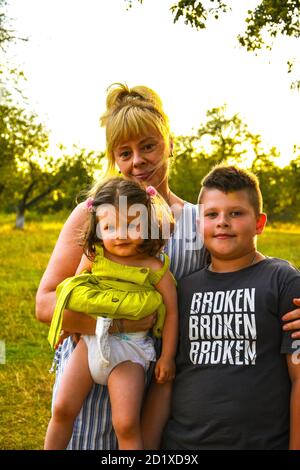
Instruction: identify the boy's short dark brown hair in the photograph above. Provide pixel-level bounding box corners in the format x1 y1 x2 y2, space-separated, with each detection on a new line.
198 164 263 215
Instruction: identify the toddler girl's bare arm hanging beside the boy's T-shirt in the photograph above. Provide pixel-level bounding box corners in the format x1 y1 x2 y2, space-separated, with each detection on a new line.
155 271 178 382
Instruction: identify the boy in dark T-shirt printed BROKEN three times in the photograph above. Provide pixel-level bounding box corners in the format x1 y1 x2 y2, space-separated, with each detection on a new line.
162 166 300 449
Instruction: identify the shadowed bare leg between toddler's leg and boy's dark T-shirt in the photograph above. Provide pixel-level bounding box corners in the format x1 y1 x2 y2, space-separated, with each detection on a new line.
142 379 173 450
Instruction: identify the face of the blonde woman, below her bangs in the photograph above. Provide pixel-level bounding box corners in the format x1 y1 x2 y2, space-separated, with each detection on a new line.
114 134 169 188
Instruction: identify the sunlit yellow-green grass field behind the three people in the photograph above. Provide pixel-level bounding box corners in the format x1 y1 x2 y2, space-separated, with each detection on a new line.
0 214 300 449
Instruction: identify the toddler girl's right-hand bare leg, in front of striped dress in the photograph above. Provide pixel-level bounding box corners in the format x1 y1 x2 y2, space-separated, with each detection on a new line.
107 361 145 450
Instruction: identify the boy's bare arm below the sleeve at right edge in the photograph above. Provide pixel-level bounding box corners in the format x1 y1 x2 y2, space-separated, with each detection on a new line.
286 352 300 450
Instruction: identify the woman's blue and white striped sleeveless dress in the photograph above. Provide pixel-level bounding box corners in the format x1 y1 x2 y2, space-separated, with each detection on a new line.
53 202 208 450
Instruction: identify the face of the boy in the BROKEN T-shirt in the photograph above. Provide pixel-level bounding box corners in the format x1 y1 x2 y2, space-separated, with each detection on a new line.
201 189 266 260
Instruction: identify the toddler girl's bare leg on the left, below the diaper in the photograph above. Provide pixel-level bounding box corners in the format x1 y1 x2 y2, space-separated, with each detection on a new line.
44 339 93 450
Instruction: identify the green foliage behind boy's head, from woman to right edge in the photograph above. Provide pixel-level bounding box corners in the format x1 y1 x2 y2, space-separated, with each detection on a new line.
170 106 300 221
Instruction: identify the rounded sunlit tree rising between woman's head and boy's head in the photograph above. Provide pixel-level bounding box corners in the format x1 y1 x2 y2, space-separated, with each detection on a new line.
170 106 256 202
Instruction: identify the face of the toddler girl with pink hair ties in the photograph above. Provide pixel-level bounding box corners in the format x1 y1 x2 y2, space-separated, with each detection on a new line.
97 206 144 257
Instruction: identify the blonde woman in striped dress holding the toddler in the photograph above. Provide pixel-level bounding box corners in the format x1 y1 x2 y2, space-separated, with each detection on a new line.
36 84 300 449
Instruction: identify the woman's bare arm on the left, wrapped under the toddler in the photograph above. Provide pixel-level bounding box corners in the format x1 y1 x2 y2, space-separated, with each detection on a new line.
36 202 96 334
